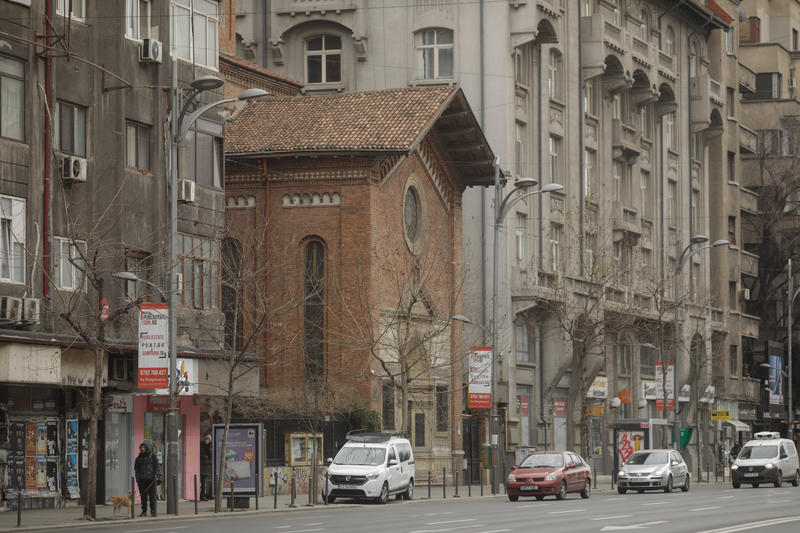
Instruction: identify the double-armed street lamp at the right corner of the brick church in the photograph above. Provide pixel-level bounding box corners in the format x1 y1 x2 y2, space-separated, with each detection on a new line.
489 157 564 494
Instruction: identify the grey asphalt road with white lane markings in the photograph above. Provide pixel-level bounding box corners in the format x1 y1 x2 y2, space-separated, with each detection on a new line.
78 485 800 533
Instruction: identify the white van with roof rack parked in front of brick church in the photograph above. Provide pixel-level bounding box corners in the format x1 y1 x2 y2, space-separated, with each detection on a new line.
322 432 415 503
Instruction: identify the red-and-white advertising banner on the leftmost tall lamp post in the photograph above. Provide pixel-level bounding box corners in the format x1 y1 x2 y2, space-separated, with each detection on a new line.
138 303 169 389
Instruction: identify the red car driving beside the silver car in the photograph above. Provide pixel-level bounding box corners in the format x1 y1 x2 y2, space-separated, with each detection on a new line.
506 451 592 502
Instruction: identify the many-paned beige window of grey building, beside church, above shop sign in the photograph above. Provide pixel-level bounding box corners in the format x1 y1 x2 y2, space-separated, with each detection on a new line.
178 234 220 309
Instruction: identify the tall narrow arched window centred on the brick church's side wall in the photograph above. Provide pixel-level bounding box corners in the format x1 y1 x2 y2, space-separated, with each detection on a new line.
303 237 325 379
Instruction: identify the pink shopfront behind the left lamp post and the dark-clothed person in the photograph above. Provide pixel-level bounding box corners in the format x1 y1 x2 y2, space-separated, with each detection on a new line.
133 394 200 500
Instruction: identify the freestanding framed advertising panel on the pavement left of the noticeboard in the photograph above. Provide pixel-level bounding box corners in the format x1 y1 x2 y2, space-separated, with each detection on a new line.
213 424 261 494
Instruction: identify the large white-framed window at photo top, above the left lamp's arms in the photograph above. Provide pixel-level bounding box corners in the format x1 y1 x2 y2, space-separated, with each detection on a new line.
170 0 219 69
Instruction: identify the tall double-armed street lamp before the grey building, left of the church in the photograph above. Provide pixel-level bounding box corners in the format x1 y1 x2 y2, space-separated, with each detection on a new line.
164 68 268 515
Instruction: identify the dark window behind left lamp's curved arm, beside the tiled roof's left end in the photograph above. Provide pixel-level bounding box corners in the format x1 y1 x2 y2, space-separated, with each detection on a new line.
178 119 222 189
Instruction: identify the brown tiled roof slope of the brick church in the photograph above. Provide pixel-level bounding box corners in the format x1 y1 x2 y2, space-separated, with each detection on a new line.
225 87 458 154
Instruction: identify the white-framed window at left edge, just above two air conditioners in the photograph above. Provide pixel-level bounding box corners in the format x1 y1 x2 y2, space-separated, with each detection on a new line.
0 195 25 283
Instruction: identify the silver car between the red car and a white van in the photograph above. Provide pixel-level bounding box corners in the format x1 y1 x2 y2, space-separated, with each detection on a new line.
617 450 689 494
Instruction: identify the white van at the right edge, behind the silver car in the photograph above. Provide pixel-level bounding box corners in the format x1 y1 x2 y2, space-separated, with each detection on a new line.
731 431 800 489
